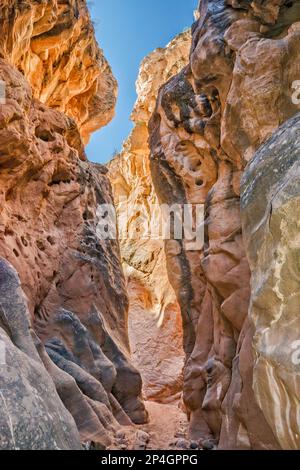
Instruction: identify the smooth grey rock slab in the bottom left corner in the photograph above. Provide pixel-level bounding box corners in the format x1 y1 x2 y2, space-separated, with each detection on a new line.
0 258 81 450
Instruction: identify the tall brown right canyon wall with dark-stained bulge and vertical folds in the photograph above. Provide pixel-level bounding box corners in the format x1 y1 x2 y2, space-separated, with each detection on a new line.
149 0 300 449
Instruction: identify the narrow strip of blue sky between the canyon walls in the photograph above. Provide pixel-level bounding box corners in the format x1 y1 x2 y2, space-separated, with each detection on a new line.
87 0 198 163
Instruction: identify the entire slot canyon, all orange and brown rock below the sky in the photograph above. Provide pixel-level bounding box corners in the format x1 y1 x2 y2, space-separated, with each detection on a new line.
0 0 300 451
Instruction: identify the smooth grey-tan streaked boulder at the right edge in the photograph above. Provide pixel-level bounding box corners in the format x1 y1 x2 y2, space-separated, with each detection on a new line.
241 114 300 449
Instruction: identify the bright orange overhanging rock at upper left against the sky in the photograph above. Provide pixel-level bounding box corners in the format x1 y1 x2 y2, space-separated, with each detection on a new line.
0 0 117 143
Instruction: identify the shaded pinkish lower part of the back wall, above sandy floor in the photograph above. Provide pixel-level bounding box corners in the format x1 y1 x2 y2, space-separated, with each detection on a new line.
128 281 184 403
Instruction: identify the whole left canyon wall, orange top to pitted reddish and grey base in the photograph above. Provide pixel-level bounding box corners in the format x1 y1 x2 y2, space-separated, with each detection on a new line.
0 1 147 449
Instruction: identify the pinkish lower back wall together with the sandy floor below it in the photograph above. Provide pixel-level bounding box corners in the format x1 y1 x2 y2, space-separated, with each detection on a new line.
118 280 191 450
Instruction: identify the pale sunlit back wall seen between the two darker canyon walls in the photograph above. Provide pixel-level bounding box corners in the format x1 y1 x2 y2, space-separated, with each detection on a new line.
109 31 191 402
